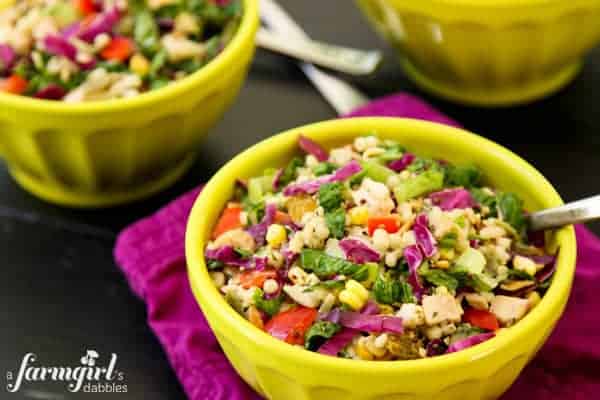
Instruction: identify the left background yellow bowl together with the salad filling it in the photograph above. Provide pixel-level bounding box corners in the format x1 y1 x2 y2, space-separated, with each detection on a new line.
0 0 259 207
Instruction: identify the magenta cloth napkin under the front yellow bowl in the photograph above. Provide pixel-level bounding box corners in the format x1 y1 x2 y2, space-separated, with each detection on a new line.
114 94 600 400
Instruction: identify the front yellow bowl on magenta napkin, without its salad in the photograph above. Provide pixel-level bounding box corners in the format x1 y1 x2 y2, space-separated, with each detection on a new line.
185 118 576 400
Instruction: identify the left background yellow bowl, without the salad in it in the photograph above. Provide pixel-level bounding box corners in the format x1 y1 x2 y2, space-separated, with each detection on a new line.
0 0 259 207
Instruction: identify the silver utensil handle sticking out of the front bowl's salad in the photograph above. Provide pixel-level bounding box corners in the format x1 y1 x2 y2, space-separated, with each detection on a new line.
529 195 600 231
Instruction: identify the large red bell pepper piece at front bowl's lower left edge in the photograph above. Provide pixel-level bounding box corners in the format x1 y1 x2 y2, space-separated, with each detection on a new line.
265 306 317 345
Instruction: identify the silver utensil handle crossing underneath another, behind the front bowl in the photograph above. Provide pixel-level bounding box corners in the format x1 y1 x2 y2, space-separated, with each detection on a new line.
260 0 370 115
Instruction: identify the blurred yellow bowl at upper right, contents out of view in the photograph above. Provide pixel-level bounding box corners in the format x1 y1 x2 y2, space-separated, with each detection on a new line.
357 0 600 106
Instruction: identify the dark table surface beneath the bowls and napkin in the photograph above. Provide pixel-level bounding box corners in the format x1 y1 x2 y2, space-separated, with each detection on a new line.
0 0 600 400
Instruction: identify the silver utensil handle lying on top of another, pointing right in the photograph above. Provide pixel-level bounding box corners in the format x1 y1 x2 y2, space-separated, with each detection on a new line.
256 28 382 75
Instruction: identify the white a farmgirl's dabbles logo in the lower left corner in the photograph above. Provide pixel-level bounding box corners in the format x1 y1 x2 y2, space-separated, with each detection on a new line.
6 350 127 393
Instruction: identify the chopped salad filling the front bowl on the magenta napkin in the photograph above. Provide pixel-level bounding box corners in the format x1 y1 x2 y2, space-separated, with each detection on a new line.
205 135 555 360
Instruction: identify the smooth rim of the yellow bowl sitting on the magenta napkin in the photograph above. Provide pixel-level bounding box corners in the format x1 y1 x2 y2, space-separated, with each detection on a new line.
185 117 576 374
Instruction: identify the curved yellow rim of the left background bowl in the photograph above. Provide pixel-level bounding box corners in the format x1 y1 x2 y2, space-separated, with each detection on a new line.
0 0 259 114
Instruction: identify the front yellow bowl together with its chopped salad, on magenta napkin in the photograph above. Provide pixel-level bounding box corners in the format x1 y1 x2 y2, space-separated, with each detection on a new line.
186 118 576 400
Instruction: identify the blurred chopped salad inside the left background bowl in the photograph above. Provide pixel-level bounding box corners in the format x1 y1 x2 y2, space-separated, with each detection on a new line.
0 0 242 102
